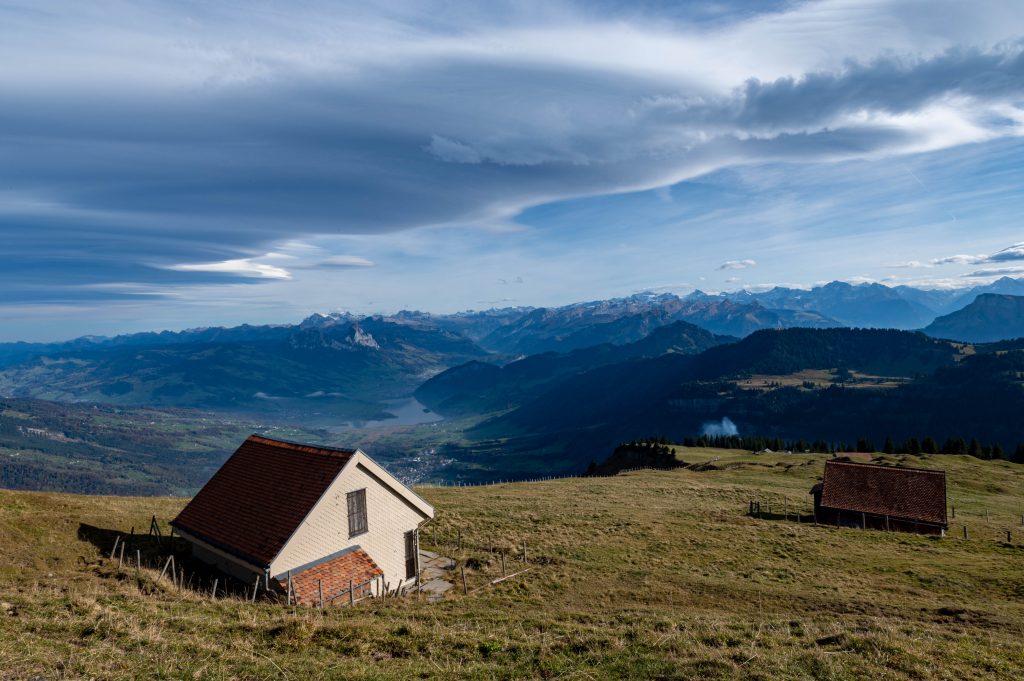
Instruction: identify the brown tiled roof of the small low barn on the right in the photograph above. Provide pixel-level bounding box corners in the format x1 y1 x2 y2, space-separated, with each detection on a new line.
821 461 946 525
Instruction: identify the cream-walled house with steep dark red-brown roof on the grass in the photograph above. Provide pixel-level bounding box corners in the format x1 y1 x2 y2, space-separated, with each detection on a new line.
171 435 434 604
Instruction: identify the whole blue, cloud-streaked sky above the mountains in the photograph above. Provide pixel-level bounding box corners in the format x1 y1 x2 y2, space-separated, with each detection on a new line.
0 0 1024 341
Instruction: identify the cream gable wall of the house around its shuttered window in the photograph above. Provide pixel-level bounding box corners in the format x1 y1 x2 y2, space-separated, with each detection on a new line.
270 459 424 588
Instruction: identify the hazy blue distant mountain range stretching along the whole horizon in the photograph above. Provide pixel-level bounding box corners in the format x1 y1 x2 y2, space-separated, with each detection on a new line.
0 278 1024 422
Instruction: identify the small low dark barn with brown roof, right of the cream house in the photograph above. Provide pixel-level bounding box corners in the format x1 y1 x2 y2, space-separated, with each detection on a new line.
811 461 949 536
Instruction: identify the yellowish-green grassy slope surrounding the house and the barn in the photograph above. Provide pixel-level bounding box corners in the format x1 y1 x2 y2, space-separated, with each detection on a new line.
0 450 1024 679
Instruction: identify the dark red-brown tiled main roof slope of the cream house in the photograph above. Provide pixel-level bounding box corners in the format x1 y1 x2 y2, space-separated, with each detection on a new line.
171 435 355 567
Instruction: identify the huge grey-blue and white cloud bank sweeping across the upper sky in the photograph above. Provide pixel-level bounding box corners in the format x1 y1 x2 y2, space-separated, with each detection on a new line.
6 0 1024 333
